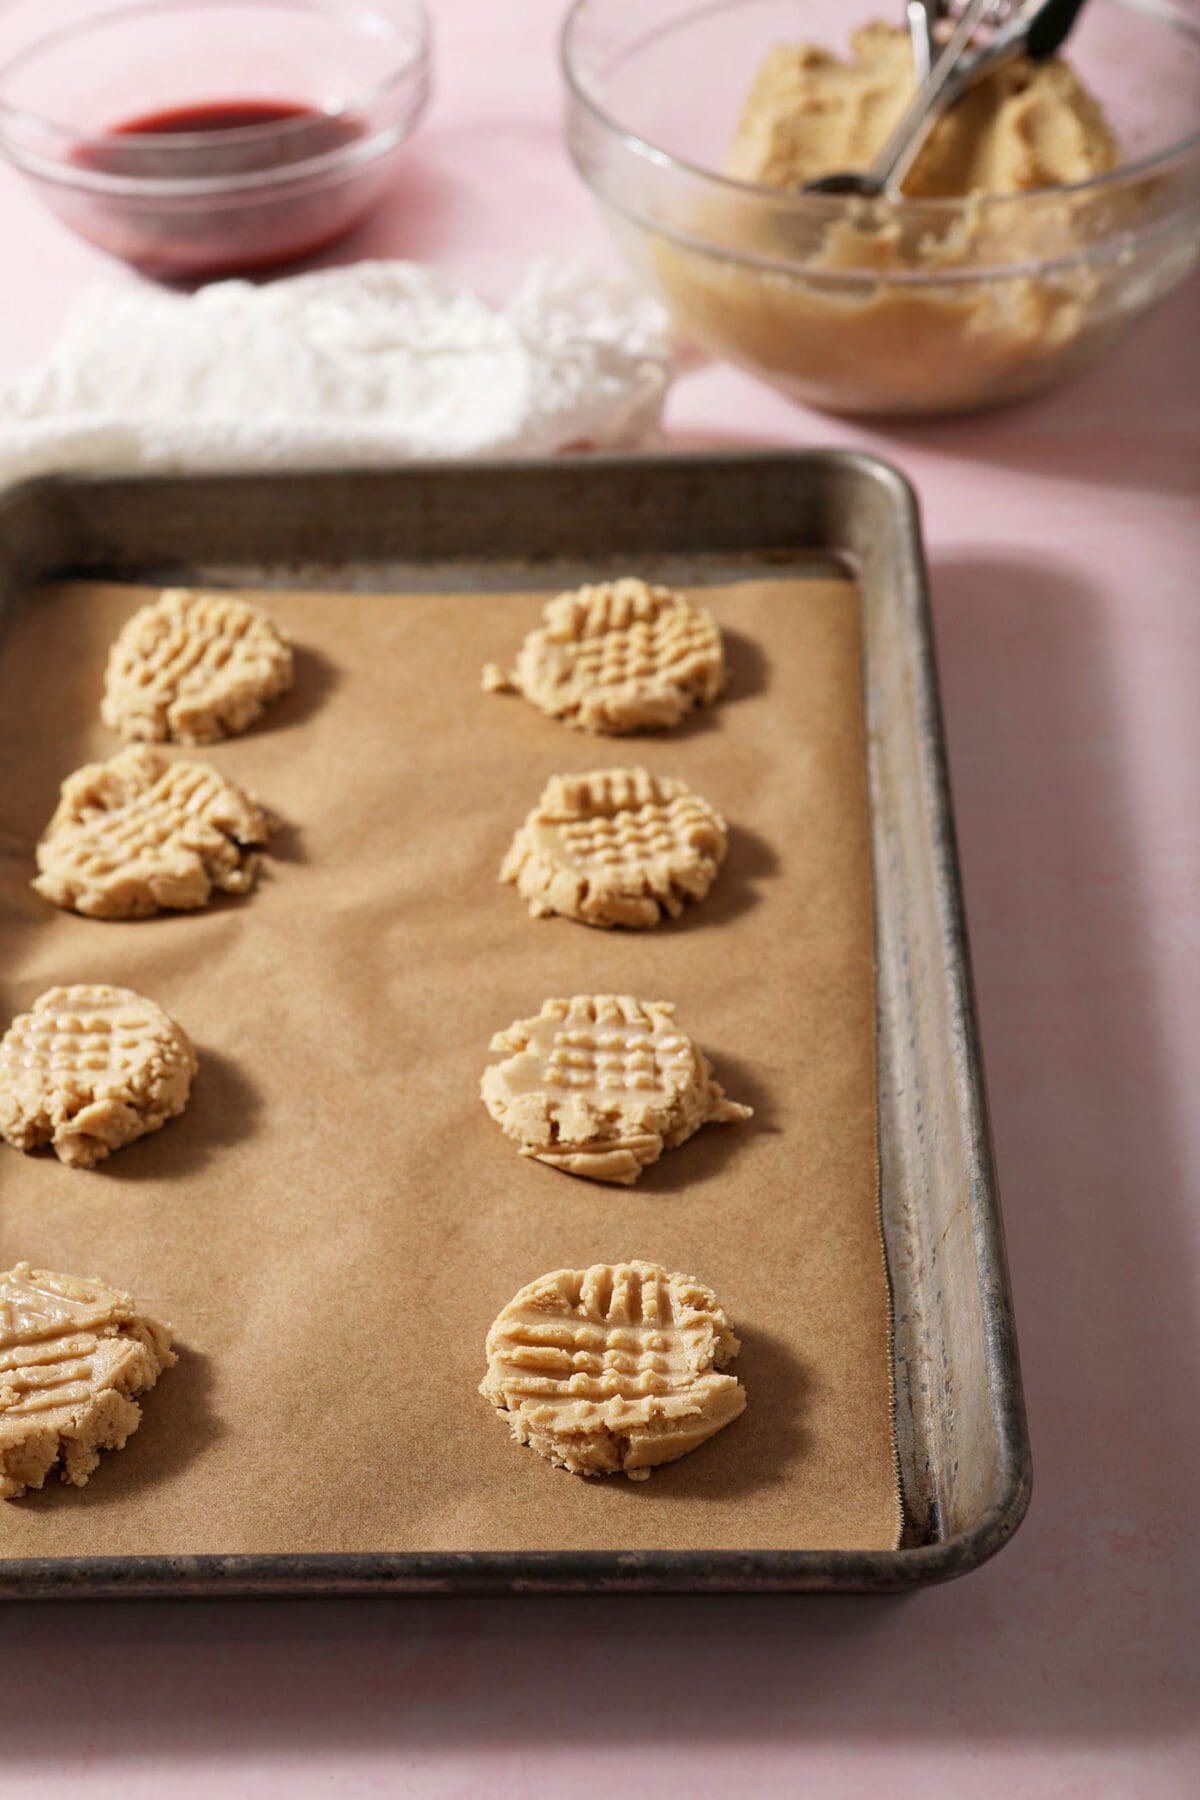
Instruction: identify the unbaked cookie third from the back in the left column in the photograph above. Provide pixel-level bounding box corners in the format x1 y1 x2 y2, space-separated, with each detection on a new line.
0 986 196 1168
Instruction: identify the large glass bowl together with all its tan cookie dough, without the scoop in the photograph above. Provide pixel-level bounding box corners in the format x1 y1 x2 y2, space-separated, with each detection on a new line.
565 0 1200 414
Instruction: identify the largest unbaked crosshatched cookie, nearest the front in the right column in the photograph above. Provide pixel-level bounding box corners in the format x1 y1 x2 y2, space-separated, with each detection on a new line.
479 1262 747 1481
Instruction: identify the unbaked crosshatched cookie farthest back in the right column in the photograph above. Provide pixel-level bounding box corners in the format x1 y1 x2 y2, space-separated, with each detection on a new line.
484 576 725 734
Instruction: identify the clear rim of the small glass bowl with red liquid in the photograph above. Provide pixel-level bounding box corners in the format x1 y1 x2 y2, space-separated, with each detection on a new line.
0 0 432 198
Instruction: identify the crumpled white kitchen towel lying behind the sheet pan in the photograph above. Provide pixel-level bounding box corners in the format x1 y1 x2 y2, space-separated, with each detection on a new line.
0 261 671 484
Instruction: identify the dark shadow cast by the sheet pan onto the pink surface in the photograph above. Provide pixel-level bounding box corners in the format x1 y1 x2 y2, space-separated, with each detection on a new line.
0 553 1200 1756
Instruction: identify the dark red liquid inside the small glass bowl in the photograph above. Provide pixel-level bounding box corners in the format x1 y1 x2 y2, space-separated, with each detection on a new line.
59 101 380 281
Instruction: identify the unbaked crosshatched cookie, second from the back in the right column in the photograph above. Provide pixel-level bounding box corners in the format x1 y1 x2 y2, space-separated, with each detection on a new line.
500 769 727 925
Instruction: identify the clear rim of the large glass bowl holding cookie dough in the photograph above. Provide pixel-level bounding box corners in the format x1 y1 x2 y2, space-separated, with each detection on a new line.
558 0 1200 220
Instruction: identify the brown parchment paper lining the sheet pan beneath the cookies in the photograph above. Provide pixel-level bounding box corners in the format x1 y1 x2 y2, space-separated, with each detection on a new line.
0 580 900 1557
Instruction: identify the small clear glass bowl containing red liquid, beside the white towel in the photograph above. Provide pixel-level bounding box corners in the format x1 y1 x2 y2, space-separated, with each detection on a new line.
0 0 430 281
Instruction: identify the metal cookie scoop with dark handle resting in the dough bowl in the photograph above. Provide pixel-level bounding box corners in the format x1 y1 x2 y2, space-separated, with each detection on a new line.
802 0 1083 200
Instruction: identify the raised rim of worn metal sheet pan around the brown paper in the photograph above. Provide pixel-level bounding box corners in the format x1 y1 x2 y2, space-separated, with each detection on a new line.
0 452 1029 1598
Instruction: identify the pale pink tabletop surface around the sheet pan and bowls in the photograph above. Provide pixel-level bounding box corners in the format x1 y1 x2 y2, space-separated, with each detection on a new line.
0 0 1200 1800
